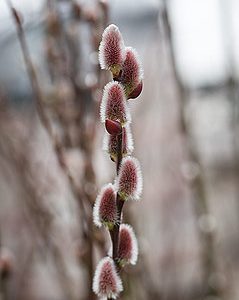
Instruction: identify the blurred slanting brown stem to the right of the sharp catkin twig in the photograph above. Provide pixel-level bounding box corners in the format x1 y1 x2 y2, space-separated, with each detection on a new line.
161 0 220 297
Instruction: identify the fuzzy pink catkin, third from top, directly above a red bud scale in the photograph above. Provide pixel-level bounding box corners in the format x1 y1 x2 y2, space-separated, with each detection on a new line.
100 81 131 126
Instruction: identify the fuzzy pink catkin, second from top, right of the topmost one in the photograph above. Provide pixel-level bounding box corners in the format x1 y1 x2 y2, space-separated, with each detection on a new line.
120 47 143 95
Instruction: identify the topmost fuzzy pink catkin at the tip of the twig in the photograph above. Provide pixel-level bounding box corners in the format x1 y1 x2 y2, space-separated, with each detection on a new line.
99 24 125 77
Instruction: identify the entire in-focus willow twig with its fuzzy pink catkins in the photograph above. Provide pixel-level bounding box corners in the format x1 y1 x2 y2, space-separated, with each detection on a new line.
93 24 143 299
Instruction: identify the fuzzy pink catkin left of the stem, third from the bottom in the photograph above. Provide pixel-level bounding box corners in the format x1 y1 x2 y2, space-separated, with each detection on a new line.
93 183 117 230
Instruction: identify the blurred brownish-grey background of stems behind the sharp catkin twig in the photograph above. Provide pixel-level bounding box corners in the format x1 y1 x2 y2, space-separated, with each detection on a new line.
0 0 239 300
